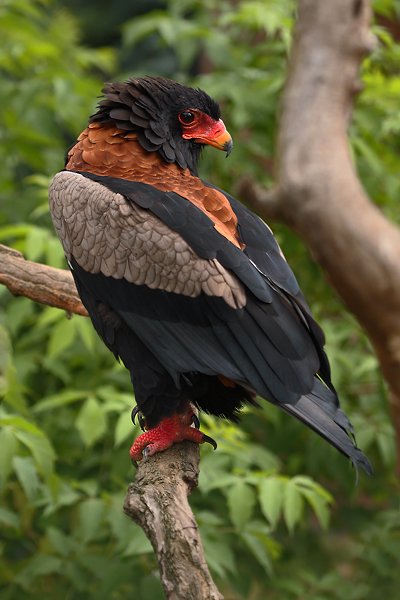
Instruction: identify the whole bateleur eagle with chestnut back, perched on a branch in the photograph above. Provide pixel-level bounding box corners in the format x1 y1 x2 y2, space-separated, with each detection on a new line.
50 77 371 473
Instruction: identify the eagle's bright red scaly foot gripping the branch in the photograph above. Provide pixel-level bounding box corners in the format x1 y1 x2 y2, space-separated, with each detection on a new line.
130 405 217 461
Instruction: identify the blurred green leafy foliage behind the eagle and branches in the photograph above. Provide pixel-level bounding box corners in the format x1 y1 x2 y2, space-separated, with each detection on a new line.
0 0 400 600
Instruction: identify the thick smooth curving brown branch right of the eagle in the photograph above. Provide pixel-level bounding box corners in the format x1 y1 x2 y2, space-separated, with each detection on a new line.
241 0 400 465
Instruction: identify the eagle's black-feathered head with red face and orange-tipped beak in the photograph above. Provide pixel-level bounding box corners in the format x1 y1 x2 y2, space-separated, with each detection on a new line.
90 77 233 173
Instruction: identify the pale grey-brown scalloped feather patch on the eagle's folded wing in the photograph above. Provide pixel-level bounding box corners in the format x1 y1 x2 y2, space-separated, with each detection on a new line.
49 171 246 308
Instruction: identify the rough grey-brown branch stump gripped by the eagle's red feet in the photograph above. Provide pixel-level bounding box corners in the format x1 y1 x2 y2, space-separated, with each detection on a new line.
124 442 223 600
